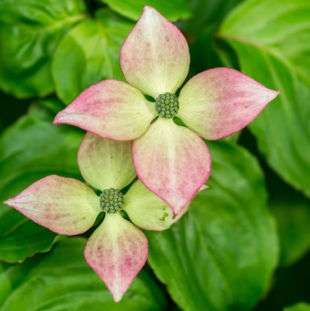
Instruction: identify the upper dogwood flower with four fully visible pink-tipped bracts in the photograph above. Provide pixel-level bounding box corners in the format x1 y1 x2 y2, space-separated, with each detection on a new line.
54 6 278 215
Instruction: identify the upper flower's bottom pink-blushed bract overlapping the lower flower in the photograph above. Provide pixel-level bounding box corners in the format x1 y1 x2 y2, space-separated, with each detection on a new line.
132 118 211 215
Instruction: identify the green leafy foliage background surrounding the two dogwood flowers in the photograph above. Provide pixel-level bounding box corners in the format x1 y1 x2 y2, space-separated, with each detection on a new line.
0 0 310 311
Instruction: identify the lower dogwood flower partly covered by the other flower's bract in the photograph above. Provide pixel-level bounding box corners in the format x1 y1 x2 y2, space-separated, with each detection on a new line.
5 133 188 302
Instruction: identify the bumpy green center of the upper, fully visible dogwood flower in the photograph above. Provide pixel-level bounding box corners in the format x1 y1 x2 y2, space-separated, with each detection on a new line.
156 93 179 118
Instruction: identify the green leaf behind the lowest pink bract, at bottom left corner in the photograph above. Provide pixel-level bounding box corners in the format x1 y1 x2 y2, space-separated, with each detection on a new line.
0 238 166 311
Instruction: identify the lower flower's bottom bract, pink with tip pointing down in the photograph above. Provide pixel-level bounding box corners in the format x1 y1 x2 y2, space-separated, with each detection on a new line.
84 213 148 301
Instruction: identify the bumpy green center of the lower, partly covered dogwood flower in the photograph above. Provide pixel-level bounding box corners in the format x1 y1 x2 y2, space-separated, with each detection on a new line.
100 188 124 213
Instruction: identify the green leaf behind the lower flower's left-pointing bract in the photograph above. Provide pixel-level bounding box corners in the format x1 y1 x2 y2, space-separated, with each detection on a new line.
0 100 82 262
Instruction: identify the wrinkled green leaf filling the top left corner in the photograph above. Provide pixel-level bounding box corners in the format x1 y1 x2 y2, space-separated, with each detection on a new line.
0 0 86 98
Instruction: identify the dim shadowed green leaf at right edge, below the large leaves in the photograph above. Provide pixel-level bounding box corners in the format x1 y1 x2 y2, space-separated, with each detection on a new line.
270 193 310 266
